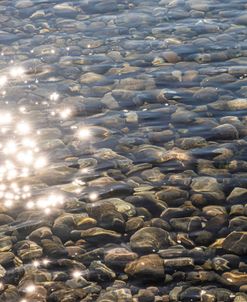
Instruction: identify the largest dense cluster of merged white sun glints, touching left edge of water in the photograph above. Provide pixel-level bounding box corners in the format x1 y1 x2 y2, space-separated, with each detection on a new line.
0 111 48 209
